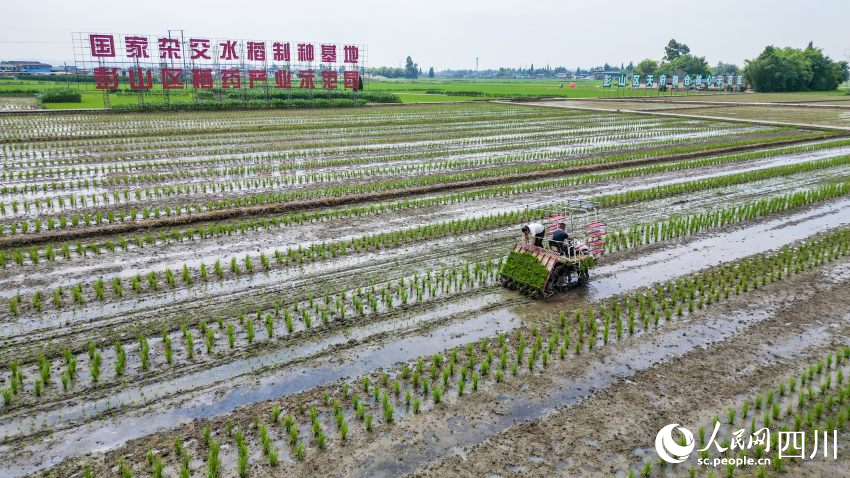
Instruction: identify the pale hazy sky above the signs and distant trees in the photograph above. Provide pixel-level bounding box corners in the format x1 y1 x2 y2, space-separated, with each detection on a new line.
0 0 850 71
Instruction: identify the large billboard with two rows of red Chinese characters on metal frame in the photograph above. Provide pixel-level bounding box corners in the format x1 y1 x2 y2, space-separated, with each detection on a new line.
73 31 366 91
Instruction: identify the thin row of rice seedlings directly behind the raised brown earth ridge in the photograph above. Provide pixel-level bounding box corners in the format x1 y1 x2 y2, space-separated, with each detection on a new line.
0 129 829 235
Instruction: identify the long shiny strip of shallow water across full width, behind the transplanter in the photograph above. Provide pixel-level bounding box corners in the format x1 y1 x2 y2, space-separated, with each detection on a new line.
0 142 850 296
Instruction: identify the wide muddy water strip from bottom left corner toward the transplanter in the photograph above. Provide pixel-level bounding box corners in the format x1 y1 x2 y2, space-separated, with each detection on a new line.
0 298 519 477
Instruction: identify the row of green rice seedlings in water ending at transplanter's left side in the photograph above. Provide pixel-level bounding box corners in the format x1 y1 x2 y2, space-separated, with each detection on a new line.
0 259 501 405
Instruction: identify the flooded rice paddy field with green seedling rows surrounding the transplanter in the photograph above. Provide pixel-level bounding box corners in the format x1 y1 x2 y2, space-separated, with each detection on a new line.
0 102 850 478
